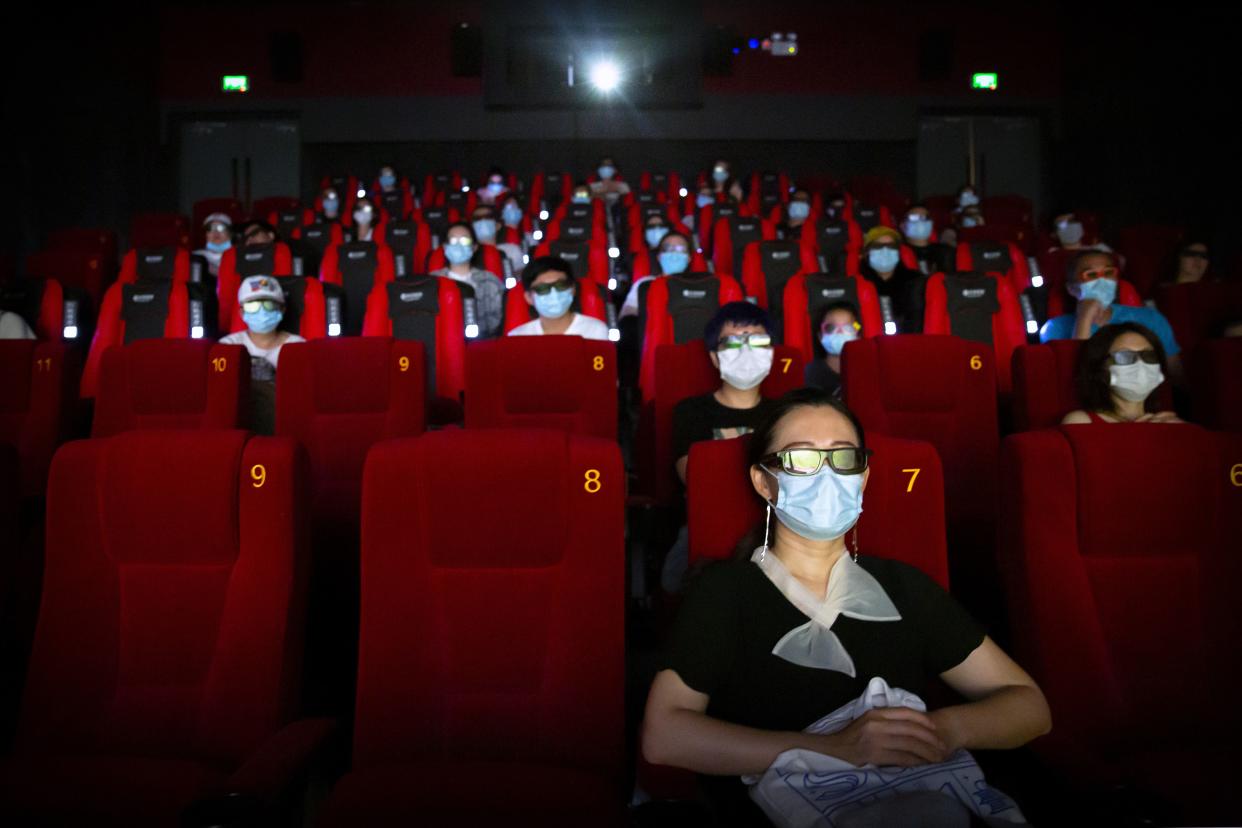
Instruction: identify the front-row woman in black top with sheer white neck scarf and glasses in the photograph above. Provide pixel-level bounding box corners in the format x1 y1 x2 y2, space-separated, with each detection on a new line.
641 389 1051 826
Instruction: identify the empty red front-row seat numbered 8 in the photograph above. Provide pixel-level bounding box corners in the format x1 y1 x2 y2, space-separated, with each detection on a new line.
320 431 627 827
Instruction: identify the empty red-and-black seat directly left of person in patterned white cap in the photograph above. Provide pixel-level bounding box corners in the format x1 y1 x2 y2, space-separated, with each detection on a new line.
82 282 193 397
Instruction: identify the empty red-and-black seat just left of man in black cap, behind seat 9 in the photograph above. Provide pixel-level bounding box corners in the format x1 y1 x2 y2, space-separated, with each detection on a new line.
363 276 466 413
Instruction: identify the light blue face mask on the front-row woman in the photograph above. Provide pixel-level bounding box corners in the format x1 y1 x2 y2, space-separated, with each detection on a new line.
764 463 863 540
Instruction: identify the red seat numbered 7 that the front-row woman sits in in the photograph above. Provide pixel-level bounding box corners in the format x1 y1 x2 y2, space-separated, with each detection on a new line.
686 433 949 588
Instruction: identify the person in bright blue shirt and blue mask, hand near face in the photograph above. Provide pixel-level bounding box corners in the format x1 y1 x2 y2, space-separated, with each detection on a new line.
1040 250 1182 382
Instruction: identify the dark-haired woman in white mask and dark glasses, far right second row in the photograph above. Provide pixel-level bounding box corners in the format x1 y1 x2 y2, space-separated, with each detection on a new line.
1061 322 1181 425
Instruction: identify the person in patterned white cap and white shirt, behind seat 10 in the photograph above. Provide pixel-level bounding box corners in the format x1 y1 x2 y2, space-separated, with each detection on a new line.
220 276 306 434
